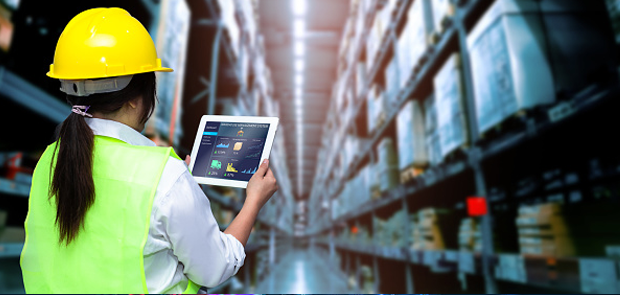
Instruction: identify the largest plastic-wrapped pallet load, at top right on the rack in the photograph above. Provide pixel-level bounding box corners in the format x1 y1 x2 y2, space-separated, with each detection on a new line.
467 0 616 133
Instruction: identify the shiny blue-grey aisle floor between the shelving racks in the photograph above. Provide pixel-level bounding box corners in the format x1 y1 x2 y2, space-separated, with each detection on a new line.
254 248 349 294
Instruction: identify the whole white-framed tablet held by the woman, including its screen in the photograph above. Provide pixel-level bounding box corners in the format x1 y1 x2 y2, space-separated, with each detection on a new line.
189 115 279 188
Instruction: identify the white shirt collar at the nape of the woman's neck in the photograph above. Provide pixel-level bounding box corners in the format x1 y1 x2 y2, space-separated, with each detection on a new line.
84 118 157 146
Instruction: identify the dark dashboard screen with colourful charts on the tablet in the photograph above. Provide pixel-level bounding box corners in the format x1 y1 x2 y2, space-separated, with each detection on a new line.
192 122 269 181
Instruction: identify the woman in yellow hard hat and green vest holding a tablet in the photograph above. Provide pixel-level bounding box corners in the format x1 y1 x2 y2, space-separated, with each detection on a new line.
21 8 277 293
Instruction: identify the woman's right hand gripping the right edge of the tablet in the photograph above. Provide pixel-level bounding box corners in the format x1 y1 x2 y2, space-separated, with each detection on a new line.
245 159 278 210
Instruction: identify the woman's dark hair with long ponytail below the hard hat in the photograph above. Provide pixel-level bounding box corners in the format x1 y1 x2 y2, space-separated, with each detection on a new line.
49 72 156 245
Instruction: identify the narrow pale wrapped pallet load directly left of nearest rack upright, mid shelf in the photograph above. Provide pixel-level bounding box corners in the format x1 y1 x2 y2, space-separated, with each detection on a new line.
433 53 468 158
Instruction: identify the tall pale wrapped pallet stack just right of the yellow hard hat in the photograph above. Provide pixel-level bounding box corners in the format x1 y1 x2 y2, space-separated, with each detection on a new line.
154 0 191 145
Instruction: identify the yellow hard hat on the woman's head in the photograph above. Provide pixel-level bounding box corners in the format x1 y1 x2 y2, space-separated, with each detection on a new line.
47 8 172 80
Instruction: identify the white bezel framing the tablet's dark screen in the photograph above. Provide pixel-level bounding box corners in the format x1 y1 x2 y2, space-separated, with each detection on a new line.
189 115 280 188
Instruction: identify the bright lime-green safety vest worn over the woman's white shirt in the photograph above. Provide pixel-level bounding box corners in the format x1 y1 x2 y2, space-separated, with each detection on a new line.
20 136 199 294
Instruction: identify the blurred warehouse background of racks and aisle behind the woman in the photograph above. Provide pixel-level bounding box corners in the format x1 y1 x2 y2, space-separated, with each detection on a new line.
0 0 620 293
